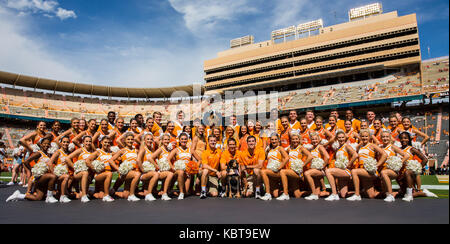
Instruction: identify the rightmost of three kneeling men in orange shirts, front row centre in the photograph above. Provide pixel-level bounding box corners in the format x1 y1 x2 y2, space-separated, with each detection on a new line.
238 136 266 198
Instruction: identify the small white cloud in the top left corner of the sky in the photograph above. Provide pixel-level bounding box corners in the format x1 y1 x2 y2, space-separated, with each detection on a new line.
0 0 77 20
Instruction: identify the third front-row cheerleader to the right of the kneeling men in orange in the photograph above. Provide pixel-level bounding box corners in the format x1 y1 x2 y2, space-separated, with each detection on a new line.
304 132 330 200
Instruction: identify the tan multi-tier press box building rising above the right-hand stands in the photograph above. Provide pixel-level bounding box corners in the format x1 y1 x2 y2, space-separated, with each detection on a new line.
204 7 421 94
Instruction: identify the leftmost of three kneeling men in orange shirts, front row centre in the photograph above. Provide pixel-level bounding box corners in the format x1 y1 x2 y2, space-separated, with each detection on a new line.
200 135 222 199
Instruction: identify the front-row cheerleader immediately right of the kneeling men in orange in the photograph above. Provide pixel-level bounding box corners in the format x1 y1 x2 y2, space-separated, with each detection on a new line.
261 133 289 201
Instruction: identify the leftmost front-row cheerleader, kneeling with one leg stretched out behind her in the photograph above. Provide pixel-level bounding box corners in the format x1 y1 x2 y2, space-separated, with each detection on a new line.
6 138 58 203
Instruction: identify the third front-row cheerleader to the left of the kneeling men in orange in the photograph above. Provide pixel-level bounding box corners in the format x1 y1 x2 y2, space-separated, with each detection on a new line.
137 133 160 201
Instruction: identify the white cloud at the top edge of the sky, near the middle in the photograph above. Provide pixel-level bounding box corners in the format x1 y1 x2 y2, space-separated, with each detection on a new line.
169 0 257 32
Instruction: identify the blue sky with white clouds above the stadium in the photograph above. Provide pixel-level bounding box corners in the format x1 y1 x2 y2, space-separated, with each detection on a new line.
0 0 449 87
